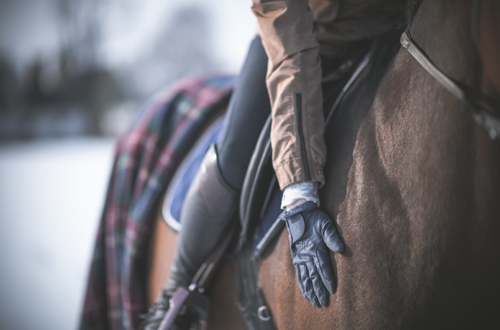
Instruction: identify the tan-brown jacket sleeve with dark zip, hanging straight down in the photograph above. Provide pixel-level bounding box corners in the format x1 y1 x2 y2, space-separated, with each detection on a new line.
252 0 326 189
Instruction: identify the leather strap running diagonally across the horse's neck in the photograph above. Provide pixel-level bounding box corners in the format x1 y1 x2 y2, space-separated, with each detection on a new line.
400 29 500 140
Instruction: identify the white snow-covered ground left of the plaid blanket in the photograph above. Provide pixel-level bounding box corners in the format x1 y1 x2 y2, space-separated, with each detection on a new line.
0 139 113 330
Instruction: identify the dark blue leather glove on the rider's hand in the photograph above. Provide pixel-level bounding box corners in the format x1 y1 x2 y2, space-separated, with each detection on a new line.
280 202 344 307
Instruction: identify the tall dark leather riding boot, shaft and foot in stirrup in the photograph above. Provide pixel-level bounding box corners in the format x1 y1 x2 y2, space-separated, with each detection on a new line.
139 145 239 330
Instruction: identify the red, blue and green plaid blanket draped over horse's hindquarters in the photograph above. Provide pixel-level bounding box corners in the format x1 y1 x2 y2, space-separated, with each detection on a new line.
79 75 235 330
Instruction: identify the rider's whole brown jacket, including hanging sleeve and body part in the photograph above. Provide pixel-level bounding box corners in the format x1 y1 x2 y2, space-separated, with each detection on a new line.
252 0 405 189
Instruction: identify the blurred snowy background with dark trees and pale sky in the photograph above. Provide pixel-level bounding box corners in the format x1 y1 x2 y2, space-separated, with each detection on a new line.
0 0 256 330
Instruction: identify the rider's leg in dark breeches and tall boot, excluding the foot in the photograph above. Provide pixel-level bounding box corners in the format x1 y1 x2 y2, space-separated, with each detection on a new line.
167 37 271 293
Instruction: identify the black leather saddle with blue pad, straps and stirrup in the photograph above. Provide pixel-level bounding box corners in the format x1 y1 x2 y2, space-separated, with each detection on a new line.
159 44 370 330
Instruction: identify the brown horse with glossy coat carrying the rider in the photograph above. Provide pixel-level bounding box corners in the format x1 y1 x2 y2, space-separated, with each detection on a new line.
149 0 500 329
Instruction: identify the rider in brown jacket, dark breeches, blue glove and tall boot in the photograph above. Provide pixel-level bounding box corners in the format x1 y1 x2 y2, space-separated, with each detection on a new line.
141 0 405 329
